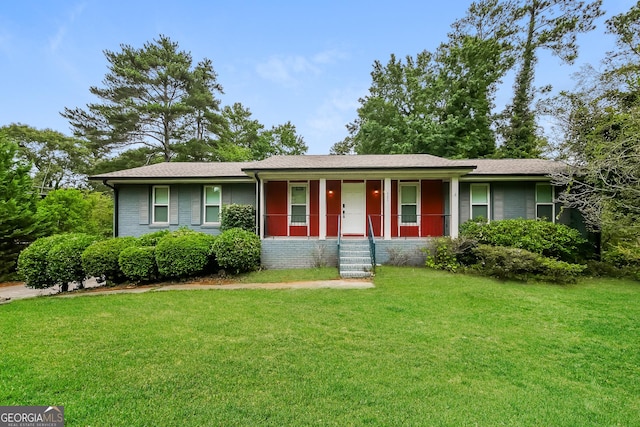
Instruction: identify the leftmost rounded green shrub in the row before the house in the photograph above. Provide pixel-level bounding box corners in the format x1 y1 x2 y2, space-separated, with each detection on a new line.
18 234 66 289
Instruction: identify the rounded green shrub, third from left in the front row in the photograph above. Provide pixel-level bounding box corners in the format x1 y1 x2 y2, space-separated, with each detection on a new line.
82 237 138 283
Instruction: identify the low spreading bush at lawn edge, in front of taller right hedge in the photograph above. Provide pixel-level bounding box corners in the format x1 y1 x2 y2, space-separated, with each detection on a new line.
472 244 586 283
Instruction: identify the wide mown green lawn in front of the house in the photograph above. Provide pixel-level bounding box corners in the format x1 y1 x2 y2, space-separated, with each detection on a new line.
0 267 640 426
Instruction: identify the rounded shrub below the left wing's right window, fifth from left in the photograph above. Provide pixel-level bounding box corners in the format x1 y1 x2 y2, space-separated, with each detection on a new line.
155 229 216 277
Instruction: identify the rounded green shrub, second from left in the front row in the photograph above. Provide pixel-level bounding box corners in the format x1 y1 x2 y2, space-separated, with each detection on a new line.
47 233 98 291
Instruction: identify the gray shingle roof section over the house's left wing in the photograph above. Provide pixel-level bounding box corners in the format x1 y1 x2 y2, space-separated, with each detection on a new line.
90 162 249 180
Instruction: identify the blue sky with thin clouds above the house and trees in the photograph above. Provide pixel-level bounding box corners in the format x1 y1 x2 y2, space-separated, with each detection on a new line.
0 0 635 154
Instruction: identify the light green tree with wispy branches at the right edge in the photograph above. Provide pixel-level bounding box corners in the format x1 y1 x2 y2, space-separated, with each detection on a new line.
550 4 640 239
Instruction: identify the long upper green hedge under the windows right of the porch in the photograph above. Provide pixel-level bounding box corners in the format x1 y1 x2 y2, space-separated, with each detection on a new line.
460 219 587 262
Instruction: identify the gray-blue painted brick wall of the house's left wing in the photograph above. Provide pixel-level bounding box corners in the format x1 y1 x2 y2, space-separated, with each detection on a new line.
117 183 255 237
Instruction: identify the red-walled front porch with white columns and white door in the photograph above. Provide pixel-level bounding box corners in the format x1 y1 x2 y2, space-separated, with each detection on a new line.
258 177 459 240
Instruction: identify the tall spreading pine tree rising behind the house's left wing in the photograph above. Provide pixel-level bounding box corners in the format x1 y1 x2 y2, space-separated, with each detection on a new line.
62 35 222 161
